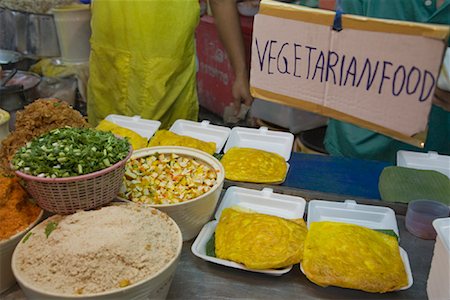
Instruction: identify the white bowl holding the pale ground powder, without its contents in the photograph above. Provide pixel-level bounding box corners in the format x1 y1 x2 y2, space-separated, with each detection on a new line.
11 205 183 300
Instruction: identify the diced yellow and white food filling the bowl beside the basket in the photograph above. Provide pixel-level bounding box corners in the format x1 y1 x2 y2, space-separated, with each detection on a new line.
120 153 217 204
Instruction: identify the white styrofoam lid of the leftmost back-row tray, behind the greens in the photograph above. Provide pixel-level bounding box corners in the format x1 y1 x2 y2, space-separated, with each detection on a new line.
105 115 161 139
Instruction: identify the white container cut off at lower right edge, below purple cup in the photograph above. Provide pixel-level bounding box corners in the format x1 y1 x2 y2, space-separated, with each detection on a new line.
427 218 450 300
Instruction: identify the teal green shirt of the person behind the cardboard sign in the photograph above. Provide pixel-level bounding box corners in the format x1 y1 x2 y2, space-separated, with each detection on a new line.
324 0 450 163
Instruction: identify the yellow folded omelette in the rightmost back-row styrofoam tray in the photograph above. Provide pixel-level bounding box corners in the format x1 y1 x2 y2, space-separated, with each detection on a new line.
220 147 287 183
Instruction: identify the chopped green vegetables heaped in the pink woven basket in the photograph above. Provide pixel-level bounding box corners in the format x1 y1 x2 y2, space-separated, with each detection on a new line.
12 128 130 178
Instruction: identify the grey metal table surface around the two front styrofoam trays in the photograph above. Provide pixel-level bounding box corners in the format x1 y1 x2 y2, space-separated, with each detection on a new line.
0 182 434 300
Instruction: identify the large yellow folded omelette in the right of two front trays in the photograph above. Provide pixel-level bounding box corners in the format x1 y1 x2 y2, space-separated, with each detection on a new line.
302 222 408 293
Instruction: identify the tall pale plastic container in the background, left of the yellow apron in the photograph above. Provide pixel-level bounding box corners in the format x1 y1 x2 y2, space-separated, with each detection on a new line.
52 4 91 64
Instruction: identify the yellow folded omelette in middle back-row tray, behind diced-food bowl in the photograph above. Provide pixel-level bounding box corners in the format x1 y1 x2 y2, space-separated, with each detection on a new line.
148 130 216 155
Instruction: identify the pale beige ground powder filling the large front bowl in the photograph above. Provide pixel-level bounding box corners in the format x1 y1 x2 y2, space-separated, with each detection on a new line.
13 204 181 295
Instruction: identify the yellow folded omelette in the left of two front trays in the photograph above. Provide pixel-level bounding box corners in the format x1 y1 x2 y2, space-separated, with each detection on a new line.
215 208 307 270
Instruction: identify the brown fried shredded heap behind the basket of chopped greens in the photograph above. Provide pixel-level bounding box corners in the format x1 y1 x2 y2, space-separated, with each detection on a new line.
0 99 89 174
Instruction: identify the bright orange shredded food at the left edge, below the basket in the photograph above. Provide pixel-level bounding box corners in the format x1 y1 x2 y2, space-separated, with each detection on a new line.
0 177 41 240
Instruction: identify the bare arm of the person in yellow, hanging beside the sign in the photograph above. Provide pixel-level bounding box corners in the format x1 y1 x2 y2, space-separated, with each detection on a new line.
209 0 253 114
